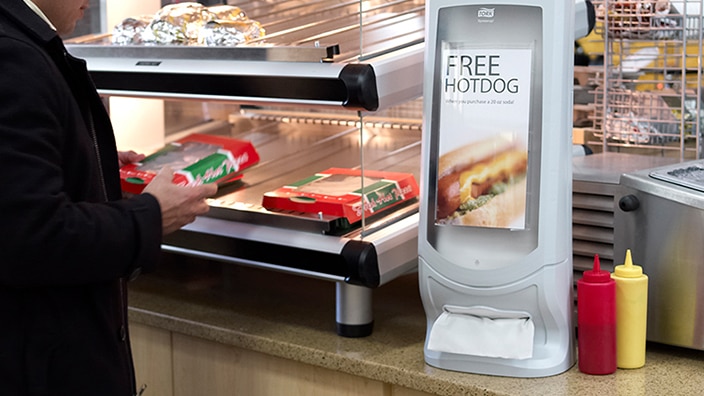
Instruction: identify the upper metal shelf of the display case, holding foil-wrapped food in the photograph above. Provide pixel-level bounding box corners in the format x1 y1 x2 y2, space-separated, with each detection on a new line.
66 0 424 112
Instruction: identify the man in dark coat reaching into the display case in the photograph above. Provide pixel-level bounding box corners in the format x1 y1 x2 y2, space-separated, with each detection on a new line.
0 0 217 396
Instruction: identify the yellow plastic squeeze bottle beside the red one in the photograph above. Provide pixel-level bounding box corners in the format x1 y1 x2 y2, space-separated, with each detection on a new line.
611 249 648 369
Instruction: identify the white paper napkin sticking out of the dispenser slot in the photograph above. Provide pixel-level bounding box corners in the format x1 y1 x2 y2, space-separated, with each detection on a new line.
428 306 535 359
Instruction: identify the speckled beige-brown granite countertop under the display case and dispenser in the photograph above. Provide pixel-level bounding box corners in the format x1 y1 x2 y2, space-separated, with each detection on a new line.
130 256 704 396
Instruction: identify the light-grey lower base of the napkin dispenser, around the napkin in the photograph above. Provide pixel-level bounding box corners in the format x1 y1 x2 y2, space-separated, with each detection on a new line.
418 257 576 378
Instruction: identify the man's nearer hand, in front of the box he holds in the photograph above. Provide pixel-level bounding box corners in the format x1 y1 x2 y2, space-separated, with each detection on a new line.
142 168 218 235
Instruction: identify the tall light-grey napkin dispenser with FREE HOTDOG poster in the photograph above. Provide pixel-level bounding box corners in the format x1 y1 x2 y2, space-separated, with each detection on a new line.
419 0 575 377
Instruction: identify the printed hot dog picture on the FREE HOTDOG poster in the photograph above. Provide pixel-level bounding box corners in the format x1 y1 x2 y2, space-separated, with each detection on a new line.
436 135 528 228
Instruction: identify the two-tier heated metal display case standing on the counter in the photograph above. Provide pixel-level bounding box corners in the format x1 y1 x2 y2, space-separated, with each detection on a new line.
67 0 424 337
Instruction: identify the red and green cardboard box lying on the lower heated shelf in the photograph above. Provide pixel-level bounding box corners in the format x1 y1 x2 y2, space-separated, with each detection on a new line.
262 168 419 224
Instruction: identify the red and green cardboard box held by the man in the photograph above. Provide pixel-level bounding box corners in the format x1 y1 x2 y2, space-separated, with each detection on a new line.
120 133 259 194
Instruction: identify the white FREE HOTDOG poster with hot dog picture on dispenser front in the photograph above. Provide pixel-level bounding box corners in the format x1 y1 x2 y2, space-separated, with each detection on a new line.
435 42 533 229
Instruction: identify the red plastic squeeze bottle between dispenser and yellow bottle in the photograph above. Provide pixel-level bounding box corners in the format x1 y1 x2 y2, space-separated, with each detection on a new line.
577 255 616 375
